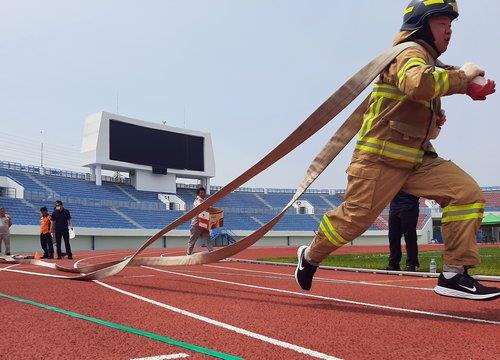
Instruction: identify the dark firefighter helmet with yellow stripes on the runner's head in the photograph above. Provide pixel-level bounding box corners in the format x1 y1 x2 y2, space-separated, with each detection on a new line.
401 0 458 30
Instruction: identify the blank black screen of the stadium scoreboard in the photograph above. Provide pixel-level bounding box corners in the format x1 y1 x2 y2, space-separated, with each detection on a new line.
109 119 205 173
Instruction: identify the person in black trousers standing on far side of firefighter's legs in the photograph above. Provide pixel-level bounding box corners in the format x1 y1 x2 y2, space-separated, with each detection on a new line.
385 191 420 271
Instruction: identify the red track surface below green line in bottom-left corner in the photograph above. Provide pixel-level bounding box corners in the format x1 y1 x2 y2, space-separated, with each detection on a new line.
0 290 217 360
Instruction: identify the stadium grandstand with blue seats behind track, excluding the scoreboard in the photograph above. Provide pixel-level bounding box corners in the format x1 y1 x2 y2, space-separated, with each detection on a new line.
0 161 500 253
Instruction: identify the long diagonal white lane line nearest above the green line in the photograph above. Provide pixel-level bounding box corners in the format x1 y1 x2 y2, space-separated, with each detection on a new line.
94 282 339 360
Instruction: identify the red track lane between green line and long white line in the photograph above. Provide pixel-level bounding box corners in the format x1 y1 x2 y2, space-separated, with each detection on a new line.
0 268 328 359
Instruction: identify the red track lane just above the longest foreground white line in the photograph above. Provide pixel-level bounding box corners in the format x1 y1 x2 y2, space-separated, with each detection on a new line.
122 262 497 358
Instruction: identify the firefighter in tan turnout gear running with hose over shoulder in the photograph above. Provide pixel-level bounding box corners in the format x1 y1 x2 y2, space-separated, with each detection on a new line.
295 0 500 300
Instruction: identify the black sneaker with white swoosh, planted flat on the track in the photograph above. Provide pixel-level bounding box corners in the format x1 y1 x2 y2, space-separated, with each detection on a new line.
434 270 500 300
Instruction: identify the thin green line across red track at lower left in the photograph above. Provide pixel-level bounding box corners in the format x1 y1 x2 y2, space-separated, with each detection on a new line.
0 292 243 360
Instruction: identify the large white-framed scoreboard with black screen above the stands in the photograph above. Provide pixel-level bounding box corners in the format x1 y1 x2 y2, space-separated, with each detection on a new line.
81 111 215 193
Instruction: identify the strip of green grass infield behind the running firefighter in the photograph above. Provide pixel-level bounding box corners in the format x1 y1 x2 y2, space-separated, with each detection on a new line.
258 247 500 275
